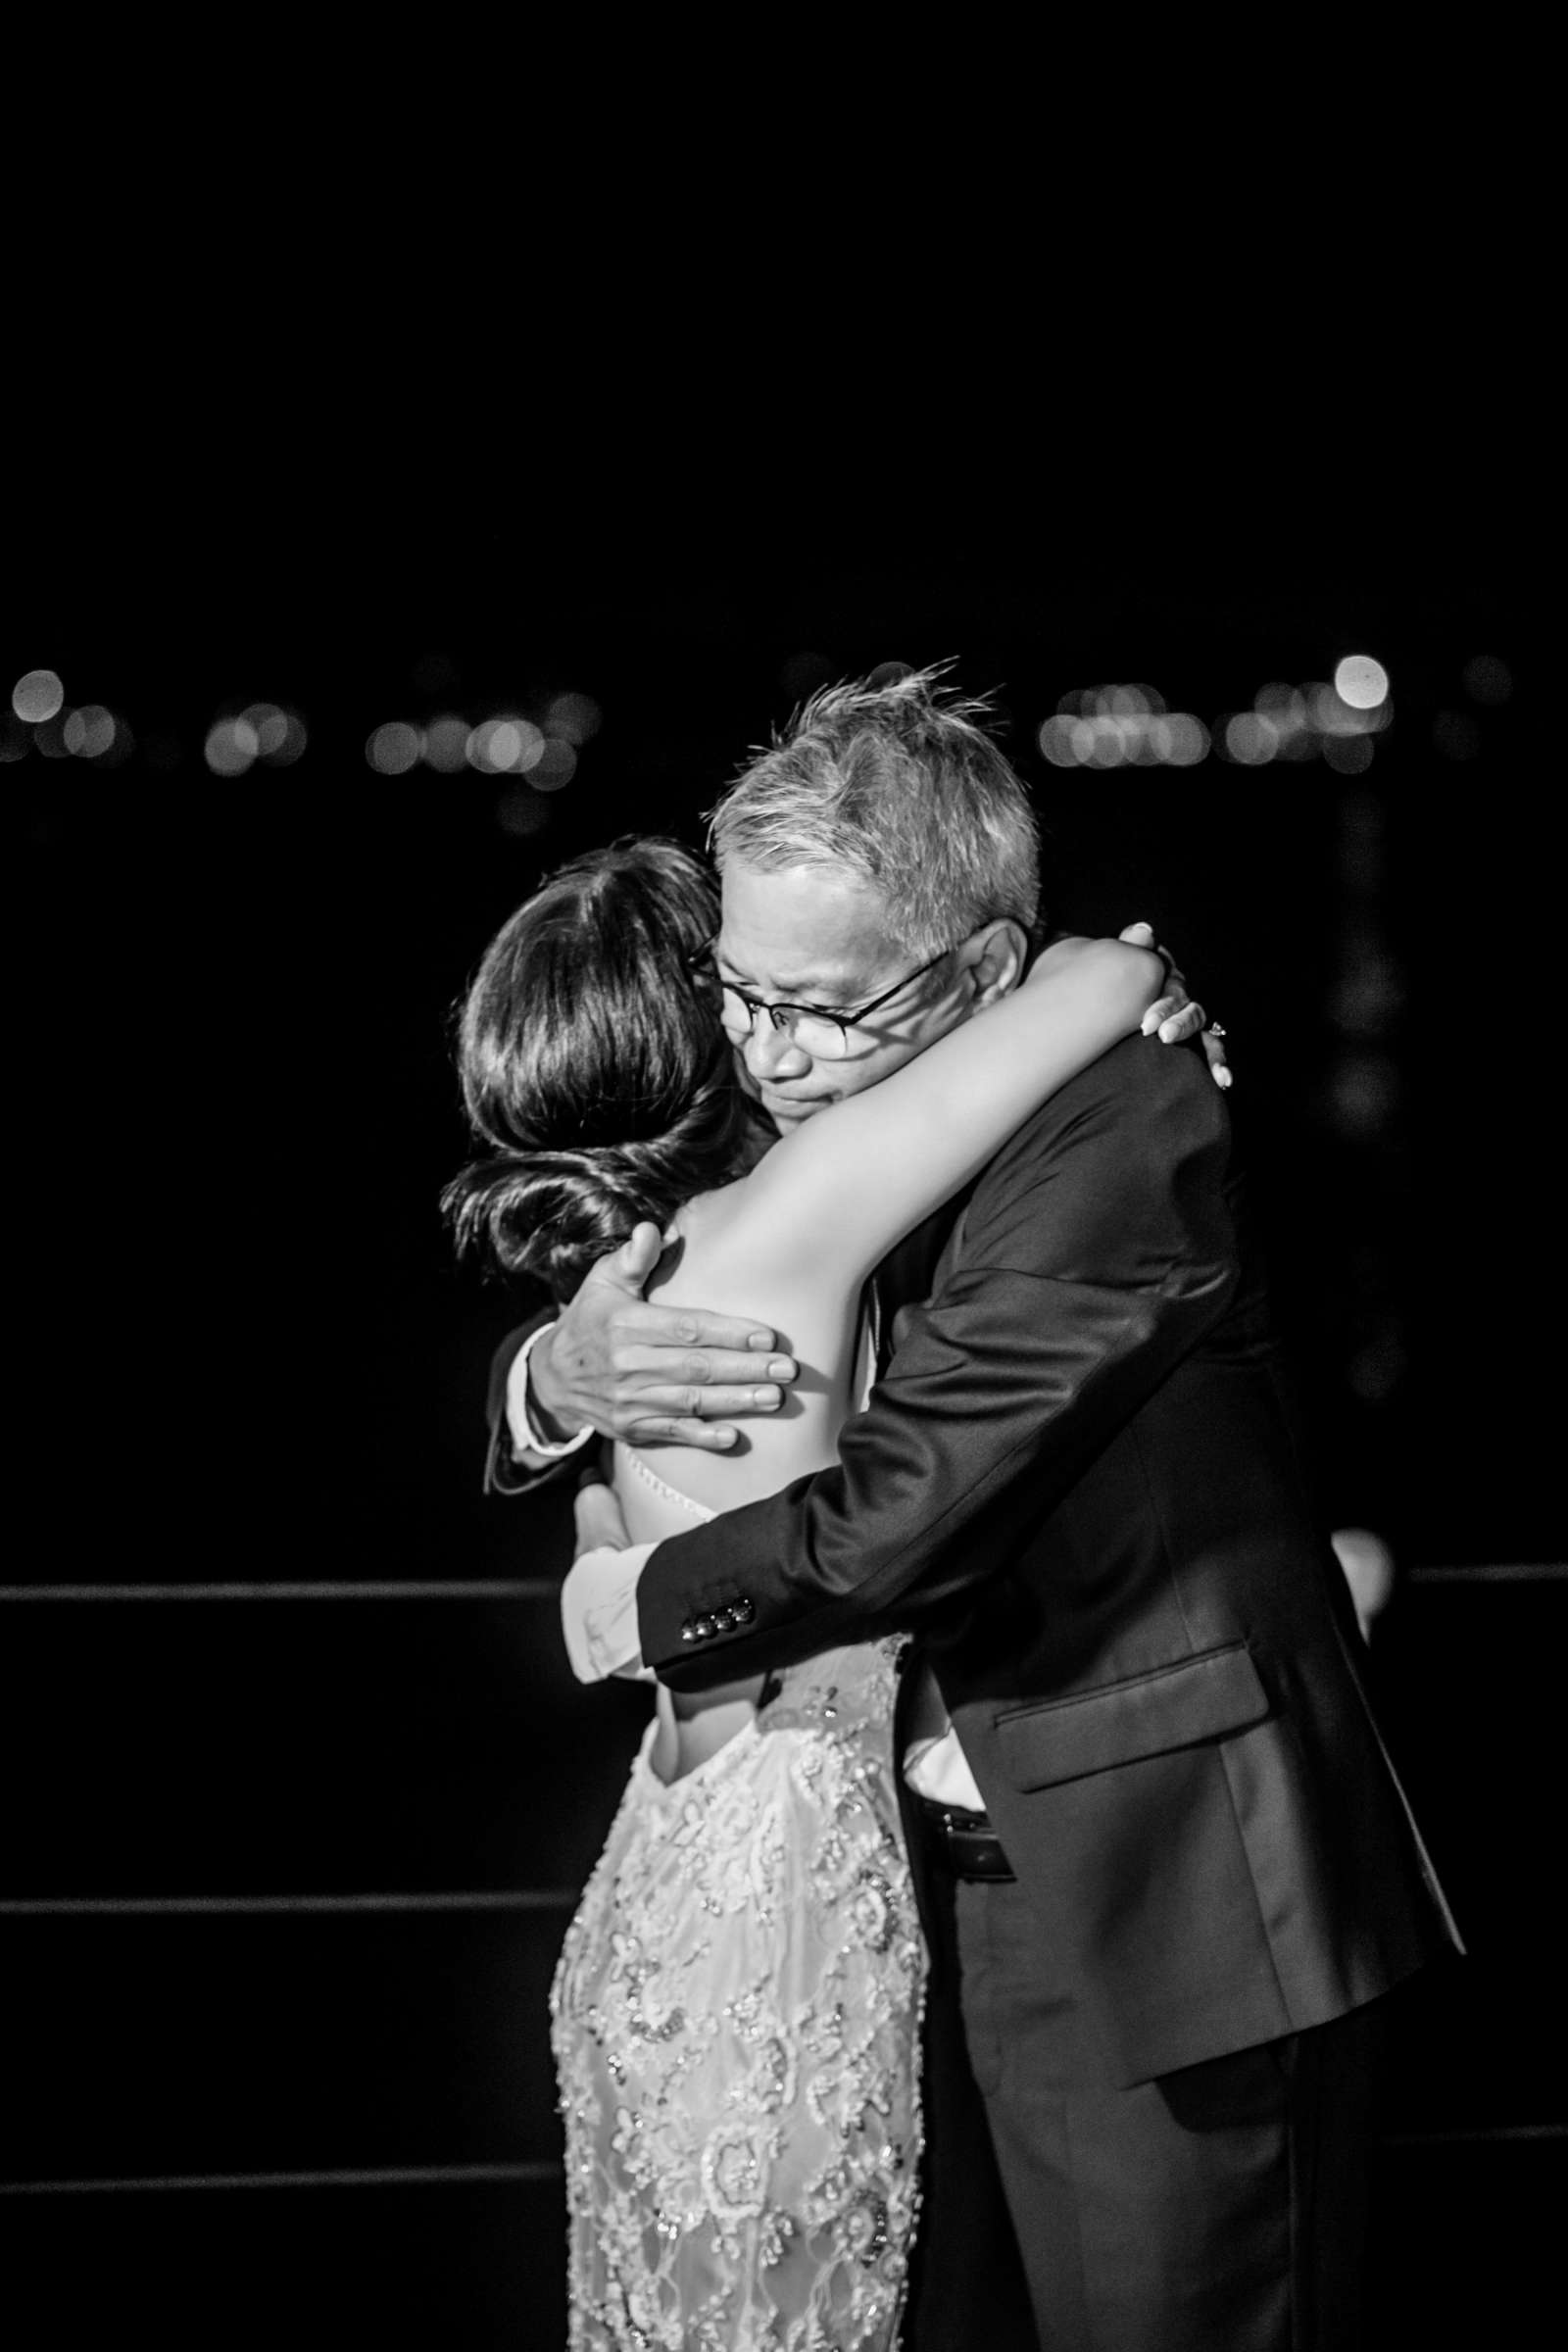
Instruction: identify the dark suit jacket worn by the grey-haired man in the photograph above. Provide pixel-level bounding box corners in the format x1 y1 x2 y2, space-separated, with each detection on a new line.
639 1040 1457 2082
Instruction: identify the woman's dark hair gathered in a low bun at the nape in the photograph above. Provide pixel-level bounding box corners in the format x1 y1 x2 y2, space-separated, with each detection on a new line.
442 840 750 1298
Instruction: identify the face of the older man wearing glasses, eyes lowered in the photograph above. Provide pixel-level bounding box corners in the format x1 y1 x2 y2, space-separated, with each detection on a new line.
714 860 973 1131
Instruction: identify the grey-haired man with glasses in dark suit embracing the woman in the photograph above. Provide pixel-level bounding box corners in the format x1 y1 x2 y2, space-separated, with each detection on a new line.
496 682 1455 2352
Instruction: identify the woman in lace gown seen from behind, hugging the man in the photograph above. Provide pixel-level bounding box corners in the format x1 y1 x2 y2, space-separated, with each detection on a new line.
449 842 1184 2352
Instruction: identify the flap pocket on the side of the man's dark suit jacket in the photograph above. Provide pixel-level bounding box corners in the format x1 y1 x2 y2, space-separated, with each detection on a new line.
997 1642 1269 1789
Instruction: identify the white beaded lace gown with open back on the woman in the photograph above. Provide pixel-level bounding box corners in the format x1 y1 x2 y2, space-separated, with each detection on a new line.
550 1448 924 2352
